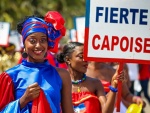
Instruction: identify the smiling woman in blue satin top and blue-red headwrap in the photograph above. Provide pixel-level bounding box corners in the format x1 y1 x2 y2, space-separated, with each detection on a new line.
0 11 73 113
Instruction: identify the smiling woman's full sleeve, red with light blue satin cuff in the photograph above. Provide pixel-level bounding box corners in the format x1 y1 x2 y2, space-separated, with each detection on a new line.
0 72 21 113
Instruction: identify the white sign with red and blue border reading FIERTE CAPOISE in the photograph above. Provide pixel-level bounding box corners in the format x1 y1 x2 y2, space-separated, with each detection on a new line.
85 0 150 63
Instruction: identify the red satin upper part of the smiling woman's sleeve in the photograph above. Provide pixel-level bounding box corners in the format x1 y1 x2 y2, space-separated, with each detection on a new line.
0 72 14 111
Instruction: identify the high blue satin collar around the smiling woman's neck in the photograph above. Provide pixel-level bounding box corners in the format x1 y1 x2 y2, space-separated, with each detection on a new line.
22 60 50 67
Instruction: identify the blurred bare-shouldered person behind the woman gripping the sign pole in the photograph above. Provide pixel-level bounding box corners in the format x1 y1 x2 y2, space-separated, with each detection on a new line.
86 61 145 113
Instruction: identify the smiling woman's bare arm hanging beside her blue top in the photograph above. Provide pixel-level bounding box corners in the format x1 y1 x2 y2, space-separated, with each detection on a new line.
57 68 74 113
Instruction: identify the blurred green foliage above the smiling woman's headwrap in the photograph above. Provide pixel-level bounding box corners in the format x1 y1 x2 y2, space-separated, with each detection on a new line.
0 0 85 30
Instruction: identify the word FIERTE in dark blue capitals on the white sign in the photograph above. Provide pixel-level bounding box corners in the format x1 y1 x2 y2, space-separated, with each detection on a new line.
96 7 148 25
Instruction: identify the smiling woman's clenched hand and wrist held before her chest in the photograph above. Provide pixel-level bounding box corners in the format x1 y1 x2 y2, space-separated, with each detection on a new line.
20 83 40 109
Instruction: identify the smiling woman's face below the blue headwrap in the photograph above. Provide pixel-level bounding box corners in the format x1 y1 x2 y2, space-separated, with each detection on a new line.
24 32 48 62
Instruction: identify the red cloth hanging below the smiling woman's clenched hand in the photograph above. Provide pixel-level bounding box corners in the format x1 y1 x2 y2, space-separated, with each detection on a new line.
32 90 52 113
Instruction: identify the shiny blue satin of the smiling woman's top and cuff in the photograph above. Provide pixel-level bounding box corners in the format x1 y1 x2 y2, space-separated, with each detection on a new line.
1 60 62 113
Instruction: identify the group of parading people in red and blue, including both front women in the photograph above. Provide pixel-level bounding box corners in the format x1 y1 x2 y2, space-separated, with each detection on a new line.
0 11 150 113
